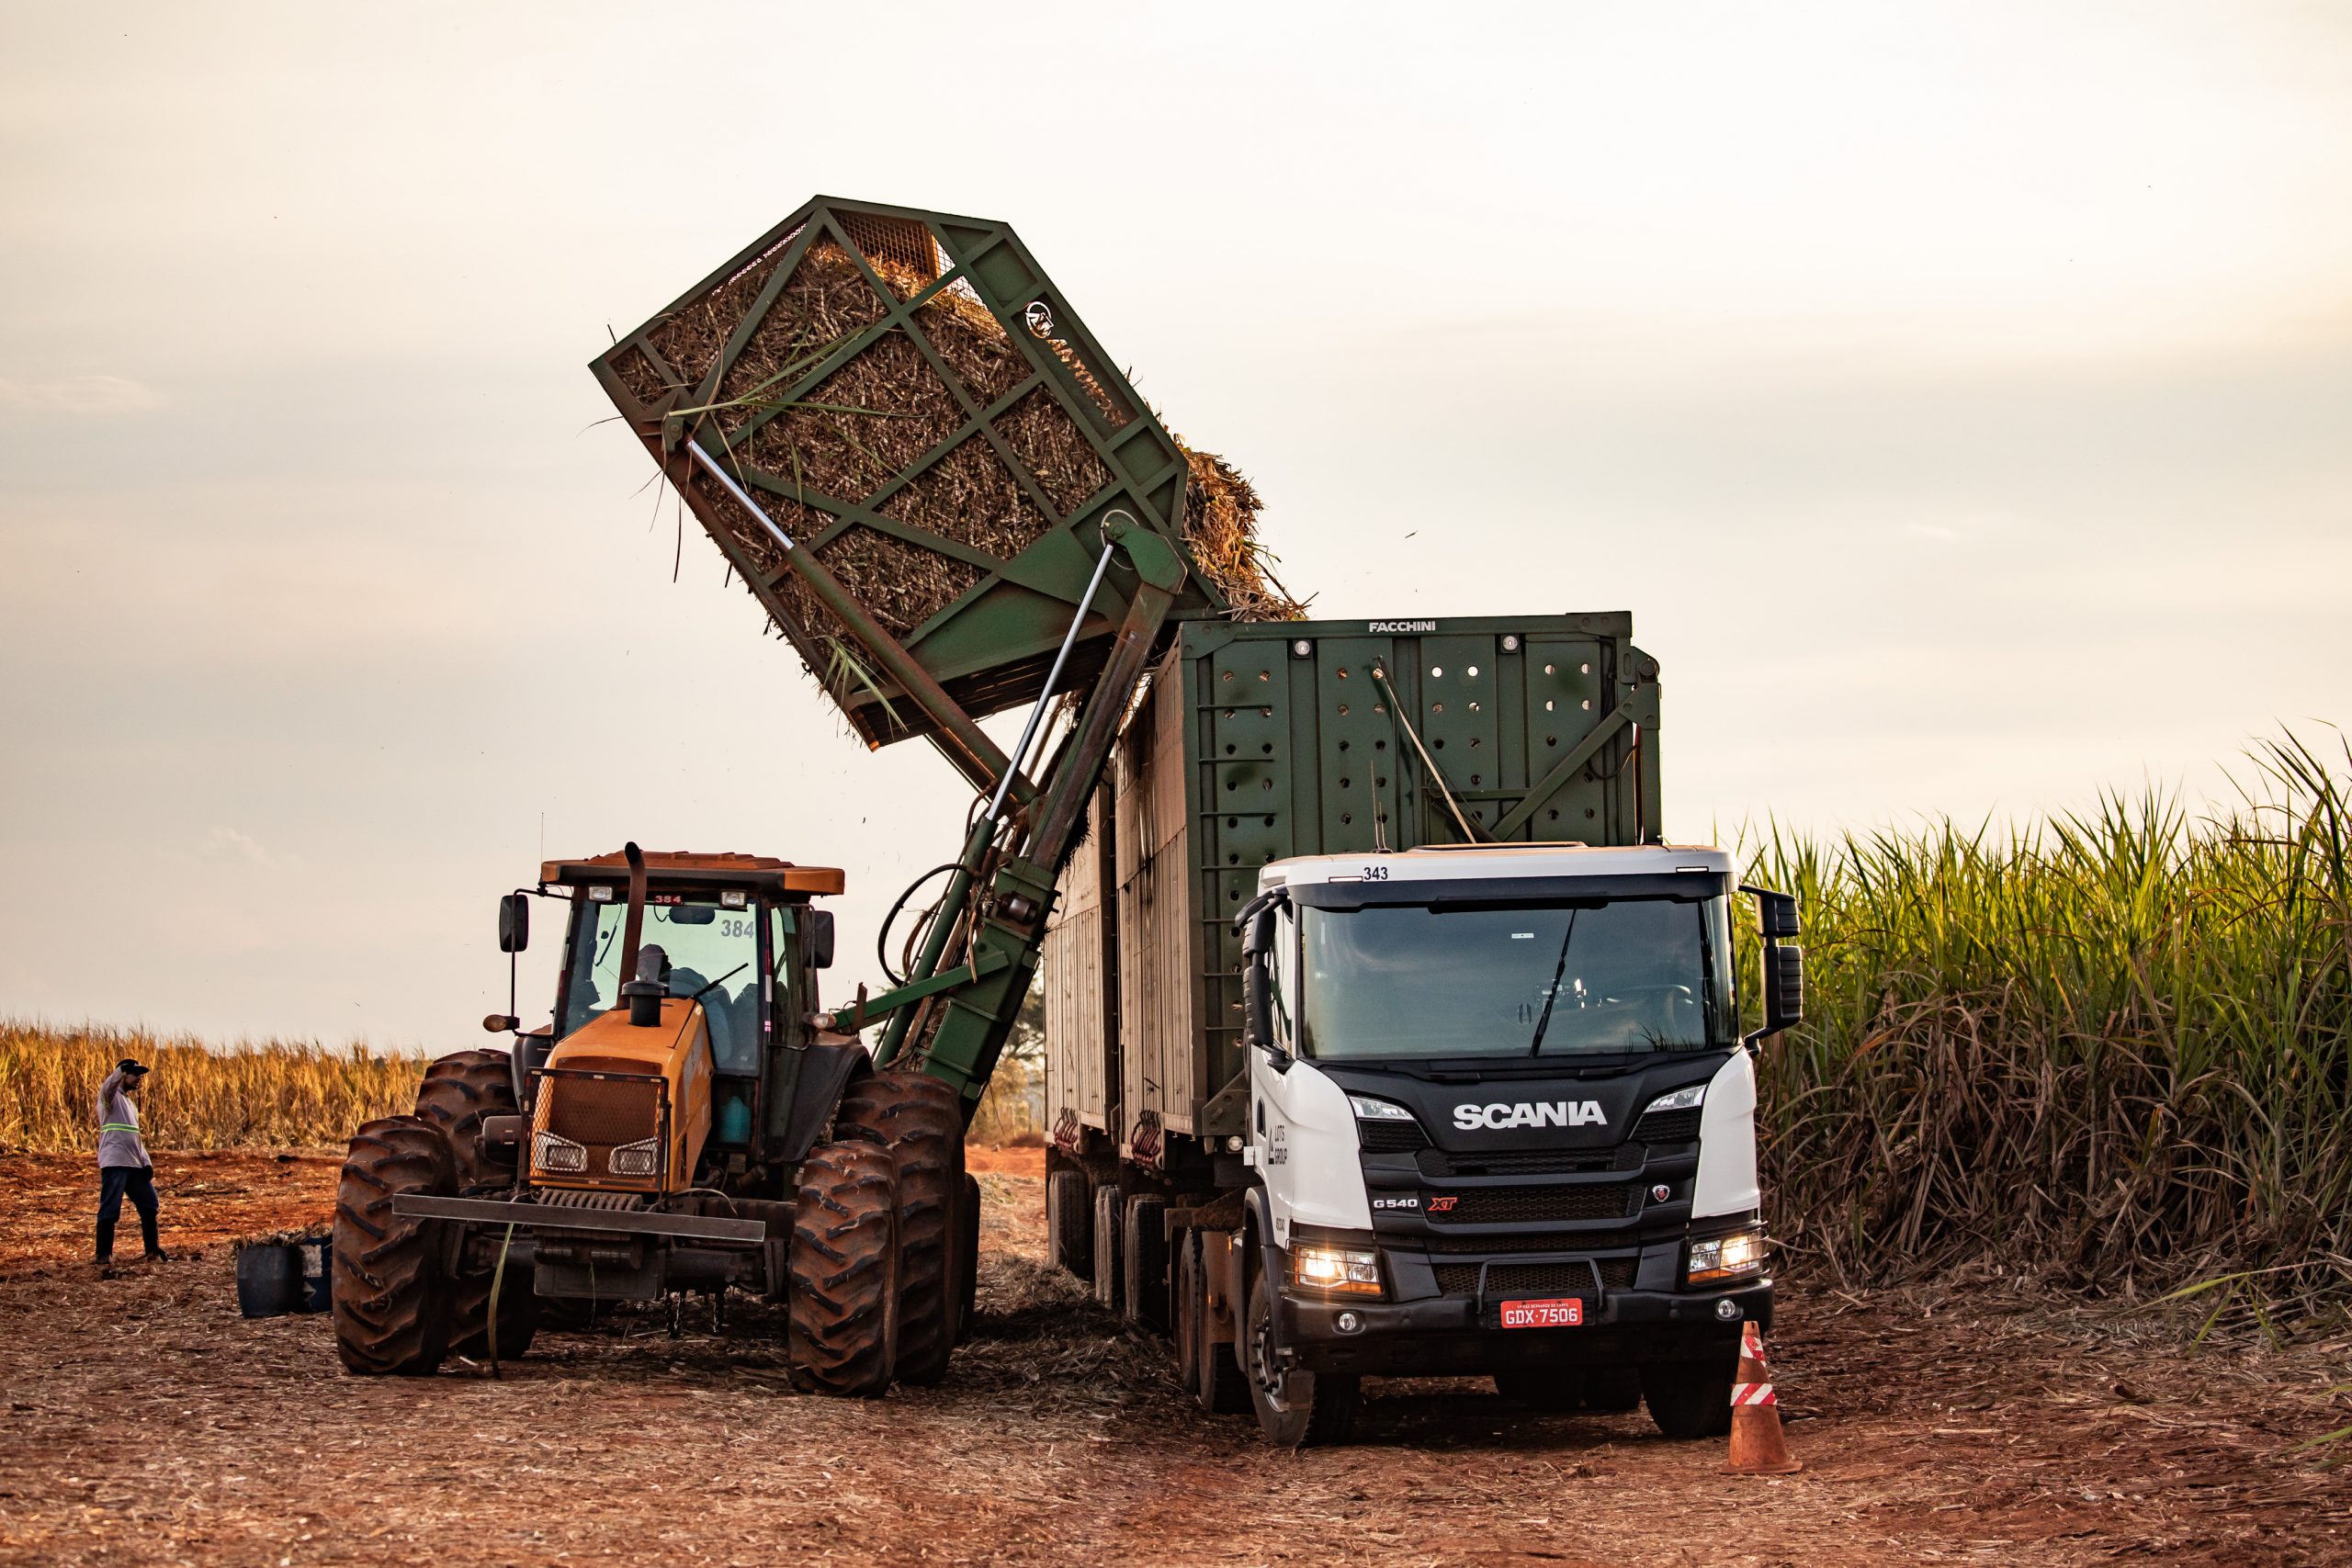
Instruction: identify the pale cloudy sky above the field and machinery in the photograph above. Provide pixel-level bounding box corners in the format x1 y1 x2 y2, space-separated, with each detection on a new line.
0 0 2352 1051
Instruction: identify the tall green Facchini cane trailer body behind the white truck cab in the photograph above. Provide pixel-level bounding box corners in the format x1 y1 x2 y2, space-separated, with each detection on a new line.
1045 614 1658 1180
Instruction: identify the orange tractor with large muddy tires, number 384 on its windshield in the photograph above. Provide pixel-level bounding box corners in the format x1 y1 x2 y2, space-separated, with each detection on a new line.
334 844 978 1394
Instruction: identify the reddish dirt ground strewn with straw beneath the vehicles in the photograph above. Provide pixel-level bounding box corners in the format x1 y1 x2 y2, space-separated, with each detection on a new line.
0 1149 2352 1568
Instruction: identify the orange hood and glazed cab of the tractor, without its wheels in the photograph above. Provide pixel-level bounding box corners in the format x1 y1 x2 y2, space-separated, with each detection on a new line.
501 846 842 1194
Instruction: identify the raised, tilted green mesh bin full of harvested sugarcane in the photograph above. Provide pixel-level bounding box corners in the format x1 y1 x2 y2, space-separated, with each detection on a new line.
593 197 1301 745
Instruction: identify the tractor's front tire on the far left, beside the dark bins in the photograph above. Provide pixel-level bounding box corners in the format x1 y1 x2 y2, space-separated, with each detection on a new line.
334 1117 457 1378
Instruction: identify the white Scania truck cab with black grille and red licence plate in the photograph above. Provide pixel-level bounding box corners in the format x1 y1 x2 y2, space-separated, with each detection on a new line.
1232 844 1802 1441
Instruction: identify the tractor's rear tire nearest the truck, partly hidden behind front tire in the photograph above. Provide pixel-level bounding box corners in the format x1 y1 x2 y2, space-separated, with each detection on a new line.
832 1069 965 1384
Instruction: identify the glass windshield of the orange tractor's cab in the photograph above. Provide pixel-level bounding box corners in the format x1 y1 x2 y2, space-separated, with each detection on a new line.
562 894 760 1072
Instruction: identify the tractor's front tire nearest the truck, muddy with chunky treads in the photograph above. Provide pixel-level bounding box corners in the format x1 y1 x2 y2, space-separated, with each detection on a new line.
788 1140 899 1399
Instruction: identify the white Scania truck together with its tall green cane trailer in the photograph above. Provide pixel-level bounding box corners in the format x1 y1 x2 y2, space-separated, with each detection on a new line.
1046 616 1802 1443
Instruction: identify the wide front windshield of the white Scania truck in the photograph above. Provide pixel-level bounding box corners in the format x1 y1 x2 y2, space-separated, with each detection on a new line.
1298 898 1738 1060
